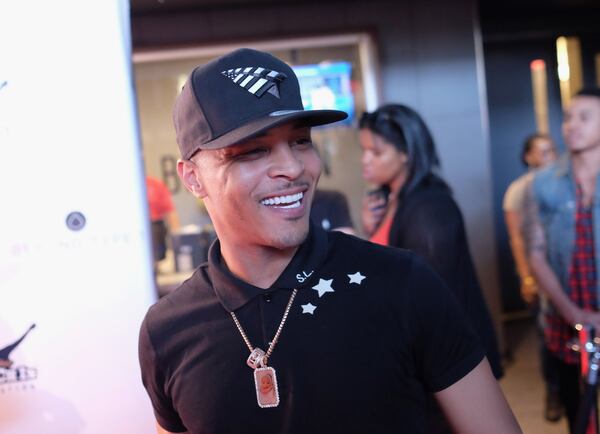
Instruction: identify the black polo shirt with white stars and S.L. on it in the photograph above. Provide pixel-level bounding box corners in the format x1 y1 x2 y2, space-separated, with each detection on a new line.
140 226 483 434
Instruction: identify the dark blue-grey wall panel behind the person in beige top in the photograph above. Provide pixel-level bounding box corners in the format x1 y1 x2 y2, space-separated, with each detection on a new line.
485 40 562 312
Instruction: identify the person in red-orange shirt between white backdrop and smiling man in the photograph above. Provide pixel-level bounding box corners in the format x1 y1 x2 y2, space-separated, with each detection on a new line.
146 176 180 273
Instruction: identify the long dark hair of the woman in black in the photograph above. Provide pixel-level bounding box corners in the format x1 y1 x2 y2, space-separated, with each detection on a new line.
359 104 440 194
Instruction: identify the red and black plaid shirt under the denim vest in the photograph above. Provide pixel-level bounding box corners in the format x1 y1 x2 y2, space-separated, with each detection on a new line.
545 185 597 364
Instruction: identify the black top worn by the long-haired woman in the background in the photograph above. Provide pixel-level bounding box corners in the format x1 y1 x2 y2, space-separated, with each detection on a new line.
389 176 503 378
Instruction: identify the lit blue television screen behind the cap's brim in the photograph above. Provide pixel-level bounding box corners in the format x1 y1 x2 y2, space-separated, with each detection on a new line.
292 62 354 125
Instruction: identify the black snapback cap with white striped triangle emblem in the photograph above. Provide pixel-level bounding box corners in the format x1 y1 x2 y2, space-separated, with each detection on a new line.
173 48 348 159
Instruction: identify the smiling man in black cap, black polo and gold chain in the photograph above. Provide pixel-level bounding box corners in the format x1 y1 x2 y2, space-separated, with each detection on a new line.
140 49 520 434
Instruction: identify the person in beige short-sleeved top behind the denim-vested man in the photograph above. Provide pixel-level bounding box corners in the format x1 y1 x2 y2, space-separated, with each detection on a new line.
502 134 562 422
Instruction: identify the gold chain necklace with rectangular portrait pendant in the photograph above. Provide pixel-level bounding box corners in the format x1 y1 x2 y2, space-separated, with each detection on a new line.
230 288 298 408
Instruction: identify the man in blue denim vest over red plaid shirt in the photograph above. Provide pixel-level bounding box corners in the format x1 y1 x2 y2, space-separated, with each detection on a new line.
525 89 600 432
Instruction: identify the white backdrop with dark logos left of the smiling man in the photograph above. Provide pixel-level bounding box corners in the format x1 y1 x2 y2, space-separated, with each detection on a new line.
0 0 154 434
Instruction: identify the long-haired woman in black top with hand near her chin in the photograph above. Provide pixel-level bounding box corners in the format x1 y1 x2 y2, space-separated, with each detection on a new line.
359 104 503 433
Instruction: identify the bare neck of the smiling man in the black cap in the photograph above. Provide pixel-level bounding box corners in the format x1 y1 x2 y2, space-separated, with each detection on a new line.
221 242 298 288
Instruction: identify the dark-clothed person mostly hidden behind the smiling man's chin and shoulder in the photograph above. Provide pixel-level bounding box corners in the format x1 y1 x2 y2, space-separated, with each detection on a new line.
310 188 356 235
